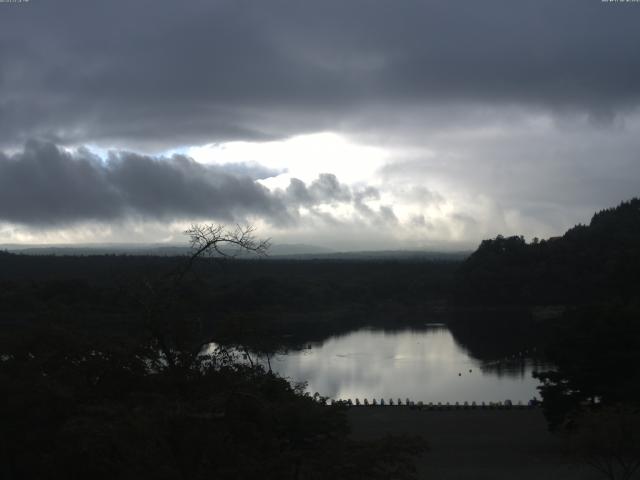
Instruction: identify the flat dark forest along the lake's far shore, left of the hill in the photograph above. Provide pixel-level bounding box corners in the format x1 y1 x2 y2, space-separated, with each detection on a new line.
0 253 459 348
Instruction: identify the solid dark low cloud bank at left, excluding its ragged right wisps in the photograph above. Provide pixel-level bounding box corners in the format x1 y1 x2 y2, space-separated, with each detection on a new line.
0 142 290 226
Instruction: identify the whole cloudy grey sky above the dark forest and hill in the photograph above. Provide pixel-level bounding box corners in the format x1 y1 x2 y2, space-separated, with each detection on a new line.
0 0 640 250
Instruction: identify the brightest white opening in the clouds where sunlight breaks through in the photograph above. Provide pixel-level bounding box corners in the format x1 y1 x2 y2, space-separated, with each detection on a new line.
175 132 458 248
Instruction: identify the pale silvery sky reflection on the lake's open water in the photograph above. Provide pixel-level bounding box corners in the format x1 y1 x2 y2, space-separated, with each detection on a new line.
260 326 538 402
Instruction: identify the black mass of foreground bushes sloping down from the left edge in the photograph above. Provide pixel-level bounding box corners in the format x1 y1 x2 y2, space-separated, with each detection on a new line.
0 326 424 479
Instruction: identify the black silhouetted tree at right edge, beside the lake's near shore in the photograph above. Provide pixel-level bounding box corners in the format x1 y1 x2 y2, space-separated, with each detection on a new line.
536 306 640 429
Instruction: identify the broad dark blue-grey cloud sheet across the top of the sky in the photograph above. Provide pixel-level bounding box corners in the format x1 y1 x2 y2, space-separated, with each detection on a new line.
0 0 640 149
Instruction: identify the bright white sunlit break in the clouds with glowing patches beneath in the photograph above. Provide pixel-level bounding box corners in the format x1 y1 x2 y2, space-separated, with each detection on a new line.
165 132 476 249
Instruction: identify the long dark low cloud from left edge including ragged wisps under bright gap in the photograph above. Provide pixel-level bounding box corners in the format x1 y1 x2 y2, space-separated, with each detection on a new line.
0 141 400 232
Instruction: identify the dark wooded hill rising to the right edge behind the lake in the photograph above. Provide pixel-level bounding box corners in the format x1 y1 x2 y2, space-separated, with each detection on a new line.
456 198 640 305
